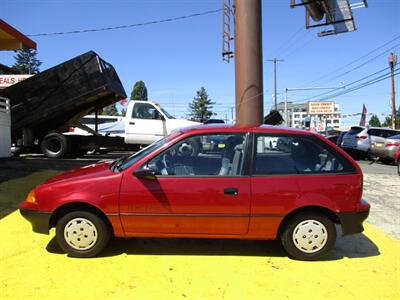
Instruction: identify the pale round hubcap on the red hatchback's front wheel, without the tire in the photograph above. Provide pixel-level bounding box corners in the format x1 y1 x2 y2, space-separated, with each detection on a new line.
64 218 97 250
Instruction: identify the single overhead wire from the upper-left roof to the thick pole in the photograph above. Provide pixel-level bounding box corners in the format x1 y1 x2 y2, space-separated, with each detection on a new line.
27 9 222 37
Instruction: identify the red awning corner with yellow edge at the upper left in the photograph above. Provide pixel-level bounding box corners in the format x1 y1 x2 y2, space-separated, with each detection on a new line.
0 19 36 50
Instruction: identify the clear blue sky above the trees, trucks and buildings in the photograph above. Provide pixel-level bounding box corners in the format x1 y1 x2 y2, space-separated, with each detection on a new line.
0 0 400 125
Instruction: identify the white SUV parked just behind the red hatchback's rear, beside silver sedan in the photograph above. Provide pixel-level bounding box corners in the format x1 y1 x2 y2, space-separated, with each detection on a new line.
341 126 400 158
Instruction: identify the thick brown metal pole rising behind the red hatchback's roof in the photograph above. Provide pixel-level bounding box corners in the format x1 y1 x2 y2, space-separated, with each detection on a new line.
235 0 263 127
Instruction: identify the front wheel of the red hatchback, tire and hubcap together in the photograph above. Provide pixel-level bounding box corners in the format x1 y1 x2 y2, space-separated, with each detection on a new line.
56 211 111 258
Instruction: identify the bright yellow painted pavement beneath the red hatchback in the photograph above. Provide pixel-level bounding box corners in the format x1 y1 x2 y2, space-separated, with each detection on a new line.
0 212 400 300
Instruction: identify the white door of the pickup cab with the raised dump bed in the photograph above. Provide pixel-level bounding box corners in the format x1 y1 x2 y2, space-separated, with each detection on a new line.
126 102 166 145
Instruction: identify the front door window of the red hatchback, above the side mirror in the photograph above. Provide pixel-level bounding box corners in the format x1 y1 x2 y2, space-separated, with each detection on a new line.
142 133 246 177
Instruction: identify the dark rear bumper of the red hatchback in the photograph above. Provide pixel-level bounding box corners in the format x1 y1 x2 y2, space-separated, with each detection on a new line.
337 200 370 235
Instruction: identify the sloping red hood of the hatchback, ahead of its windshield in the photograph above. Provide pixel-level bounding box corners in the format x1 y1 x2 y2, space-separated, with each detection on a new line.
43 161 115 185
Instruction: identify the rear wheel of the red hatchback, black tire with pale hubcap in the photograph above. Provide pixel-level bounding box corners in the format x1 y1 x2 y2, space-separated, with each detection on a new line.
281 212 336 260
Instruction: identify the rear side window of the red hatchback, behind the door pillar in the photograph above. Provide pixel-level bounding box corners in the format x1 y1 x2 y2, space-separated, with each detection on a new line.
253 135 356 175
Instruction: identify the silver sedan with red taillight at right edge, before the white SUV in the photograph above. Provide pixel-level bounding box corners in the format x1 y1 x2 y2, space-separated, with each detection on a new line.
371 134 400 163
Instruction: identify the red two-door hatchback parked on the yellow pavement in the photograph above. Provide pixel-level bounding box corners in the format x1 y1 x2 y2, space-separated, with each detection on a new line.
20 125 370 260
